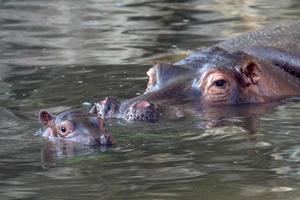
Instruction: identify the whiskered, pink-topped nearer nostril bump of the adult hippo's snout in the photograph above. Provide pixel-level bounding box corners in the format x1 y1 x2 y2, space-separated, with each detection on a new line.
123 100 160 122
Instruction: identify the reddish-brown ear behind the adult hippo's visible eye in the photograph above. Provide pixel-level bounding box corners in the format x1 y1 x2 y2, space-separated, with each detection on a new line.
240 60 260 86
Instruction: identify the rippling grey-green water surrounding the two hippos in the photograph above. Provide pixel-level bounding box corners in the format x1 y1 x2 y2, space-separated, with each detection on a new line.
0 0 300 200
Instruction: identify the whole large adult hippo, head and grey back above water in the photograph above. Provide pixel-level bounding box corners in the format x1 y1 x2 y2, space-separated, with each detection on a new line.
90 21 300 121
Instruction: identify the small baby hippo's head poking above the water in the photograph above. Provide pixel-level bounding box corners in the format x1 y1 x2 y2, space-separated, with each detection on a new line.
39 110 115 145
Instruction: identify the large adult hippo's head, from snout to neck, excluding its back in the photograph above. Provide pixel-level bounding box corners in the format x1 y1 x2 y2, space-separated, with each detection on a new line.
91 48 300 121
